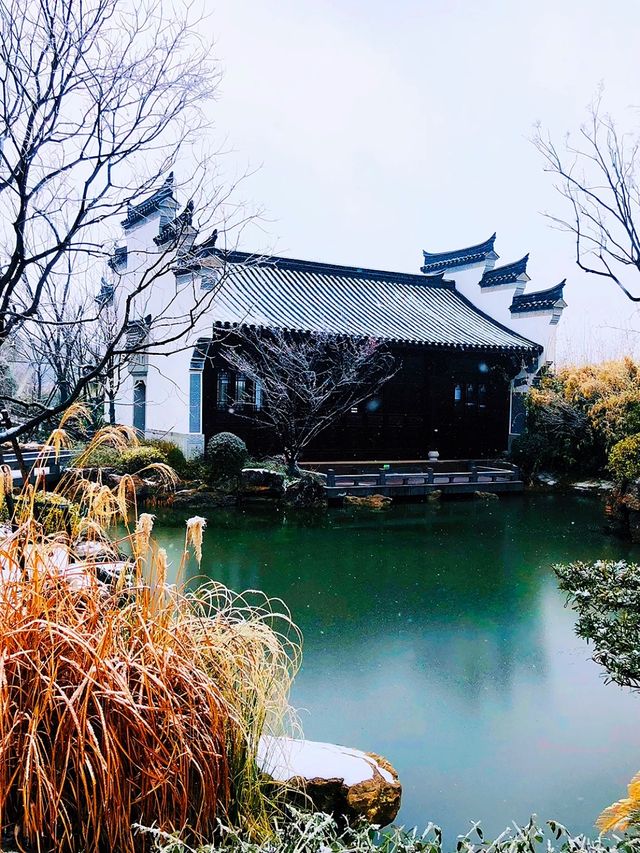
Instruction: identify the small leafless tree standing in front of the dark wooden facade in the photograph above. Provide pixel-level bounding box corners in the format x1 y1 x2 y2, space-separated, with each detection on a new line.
222 327 398 473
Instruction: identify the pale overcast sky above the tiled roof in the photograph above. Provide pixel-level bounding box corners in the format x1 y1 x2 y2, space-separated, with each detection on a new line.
201 0 640 360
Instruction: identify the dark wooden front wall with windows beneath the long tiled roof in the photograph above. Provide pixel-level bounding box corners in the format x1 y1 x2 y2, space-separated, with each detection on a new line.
202 345 521 461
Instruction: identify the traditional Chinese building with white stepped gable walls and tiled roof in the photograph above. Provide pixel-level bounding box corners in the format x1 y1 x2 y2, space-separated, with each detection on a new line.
106 176 565 460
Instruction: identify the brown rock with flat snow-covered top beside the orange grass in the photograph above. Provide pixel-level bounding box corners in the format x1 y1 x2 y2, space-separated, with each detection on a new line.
258 736 402 826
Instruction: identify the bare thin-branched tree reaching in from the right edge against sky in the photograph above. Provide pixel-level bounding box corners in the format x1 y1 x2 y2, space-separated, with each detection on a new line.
533 95 640 302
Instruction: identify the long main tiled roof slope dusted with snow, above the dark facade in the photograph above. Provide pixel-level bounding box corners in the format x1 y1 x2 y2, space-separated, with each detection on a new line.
200 248 540 353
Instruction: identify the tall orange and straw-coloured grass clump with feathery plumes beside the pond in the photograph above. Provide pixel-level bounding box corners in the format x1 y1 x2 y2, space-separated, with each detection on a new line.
0 416 300 853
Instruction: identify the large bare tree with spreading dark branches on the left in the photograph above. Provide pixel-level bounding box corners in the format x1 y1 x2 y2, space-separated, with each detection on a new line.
0 0 245 441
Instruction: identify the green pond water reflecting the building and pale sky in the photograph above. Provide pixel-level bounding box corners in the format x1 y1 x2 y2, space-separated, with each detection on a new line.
156 495 640 838
